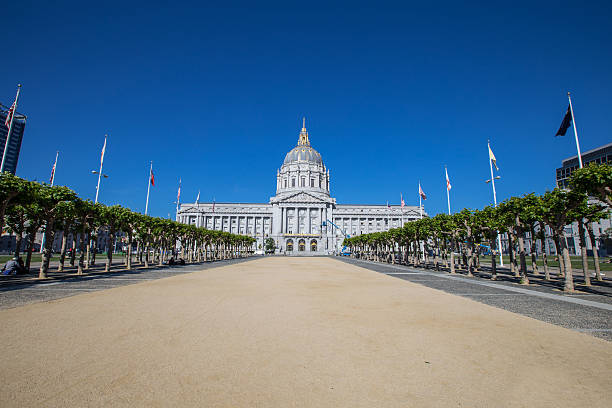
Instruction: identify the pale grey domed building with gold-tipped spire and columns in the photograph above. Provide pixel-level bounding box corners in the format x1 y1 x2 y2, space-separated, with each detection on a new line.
176 124 427 255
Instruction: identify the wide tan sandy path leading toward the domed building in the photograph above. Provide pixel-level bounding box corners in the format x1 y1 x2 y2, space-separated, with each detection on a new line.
0 257 612 407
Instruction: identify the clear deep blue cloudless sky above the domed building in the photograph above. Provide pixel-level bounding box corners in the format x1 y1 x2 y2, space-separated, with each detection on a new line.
0 1 612 217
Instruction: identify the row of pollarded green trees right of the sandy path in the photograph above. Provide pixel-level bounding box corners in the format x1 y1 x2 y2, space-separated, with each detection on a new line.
344 164 612 291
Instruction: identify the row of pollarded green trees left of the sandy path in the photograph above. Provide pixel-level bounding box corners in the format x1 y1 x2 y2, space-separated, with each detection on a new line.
0 172 255 278
